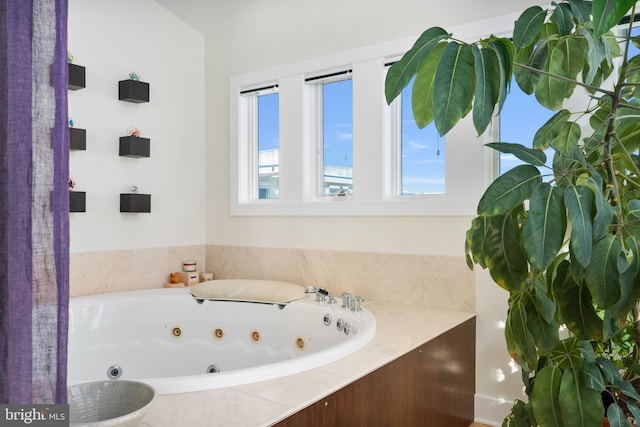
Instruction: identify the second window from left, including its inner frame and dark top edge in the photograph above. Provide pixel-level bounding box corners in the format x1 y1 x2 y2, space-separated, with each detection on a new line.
306 71 353 196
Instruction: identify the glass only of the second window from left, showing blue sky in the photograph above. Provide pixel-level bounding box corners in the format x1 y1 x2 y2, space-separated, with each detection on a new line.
322 79 353 195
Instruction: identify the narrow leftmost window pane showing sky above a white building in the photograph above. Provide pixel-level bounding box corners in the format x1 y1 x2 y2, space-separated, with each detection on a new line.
258 92 280 199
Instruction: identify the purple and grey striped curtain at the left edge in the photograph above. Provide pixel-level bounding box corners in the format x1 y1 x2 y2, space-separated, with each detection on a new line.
0 0 69 404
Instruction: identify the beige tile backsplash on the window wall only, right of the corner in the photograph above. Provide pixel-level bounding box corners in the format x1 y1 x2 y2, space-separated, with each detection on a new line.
206 245 476 312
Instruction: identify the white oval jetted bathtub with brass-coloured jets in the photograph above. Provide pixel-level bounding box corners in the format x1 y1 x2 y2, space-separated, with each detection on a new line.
68 281 376 394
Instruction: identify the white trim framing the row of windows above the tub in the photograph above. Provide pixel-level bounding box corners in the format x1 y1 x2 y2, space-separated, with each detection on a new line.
229 10 517 216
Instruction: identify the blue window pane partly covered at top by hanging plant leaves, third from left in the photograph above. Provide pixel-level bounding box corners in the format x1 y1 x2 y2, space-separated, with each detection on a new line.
400 80 444 195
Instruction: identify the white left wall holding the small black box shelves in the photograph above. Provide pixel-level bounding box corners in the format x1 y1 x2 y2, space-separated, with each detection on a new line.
68 0 206 252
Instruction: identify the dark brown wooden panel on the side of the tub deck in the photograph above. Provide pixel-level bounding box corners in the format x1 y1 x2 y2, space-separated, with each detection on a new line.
276 318 475 427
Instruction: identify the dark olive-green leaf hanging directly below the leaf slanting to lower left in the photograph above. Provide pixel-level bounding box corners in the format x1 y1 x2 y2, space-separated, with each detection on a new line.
482 215 528 291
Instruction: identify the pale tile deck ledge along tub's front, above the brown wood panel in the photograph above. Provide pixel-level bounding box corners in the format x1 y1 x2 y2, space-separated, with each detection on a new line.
142 302 474 427
